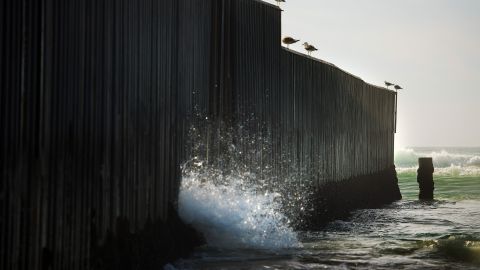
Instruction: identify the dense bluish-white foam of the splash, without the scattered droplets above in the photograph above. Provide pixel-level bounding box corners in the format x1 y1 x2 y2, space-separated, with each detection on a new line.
179 170 301 249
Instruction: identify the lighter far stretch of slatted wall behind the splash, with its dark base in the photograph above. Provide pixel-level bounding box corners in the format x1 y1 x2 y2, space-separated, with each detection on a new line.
179 0 401 226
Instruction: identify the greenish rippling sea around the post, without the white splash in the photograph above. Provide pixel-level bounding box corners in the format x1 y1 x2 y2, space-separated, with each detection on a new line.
172 148 480 270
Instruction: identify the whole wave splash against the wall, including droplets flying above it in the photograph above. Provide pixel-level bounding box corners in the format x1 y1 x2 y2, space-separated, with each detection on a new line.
179 121 312 249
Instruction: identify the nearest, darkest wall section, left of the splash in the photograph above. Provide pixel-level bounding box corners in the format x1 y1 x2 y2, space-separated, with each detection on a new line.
0 0 202 270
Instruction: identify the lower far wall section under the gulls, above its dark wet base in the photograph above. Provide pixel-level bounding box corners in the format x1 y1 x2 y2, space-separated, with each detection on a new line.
279 49 395 184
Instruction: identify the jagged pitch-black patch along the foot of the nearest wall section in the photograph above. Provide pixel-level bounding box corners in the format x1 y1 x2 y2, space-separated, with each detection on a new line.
42 205 205 270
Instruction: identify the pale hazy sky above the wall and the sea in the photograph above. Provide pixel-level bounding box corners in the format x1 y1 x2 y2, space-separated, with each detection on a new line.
269 0 480 147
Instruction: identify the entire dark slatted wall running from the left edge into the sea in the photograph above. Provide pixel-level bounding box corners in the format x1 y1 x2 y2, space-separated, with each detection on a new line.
0 0 399 269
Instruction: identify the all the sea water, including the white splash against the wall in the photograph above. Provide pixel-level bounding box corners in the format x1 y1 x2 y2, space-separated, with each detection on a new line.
175 148 480 269
